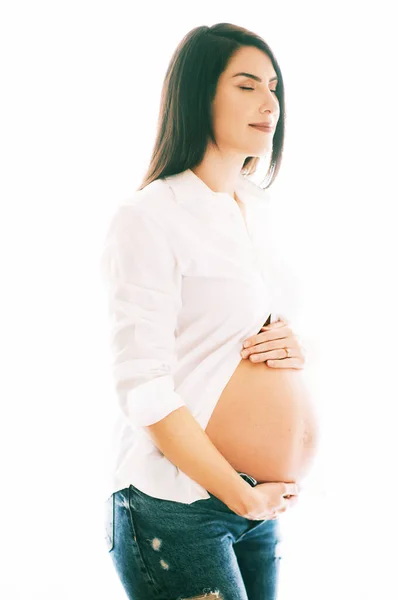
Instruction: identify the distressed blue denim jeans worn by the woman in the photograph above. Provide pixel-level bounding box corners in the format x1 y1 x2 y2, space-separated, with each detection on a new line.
105 473 281 600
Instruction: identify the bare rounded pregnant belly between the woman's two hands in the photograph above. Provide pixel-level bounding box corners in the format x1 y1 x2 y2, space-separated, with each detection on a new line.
205 359 317 483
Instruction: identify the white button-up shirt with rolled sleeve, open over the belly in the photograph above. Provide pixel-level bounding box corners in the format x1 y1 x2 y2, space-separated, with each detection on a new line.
101 169 298 503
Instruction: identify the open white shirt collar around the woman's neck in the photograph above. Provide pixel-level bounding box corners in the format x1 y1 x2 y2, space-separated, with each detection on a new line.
165 169 269 209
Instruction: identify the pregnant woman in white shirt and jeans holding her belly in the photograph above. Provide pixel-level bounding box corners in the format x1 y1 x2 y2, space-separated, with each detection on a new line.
102 23 317 600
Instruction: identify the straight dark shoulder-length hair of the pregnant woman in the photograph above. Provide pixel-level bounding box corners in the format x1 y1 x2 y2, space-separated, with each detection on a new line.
137 23 285 191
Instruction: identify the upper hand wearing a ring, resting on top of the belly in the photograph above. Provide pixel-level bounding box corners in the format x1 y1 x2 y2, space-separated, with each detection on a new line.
241 319 306 369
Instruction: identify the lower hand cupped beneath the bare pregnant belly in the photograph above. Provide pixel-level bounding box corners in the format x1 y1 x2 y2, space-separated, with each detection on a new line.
241 481 300 521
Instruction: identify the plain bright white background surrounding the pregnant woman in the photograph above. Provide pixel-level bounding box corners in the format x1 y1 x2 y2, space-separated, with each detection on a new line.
0 0 399 600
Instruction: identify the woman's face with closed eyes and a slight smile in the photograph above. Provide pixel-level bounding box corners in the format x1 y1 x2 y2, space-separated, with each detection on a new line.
212 46 280 158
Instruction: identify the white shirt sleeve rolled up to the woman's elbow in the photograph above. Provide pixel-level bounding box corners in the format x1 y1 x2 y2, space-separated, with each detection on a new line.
100 205 185 427
